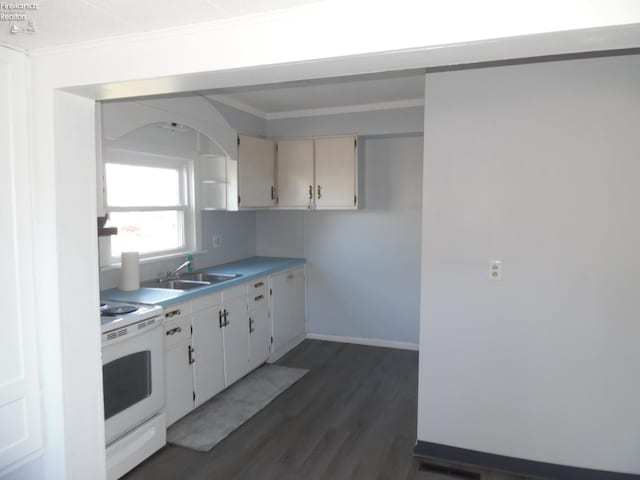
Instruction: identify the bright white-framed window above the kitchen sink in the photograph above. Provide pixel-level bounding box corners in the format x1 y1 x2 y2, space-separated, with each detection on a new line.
104 149 195 264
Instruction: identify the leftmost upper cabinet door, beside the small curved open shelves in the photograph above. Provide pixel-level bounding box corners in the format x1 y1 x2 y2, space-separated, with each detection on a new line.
238 135 275 208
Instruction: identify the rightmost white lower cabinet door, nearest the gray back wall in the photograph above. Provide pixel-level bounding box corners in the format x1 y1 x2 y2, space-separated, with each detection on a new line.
270 267 306 361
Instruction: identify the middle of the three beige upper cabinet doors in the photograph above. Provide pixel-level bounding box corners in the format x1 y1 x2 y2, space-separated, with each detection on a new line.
277 138 314 209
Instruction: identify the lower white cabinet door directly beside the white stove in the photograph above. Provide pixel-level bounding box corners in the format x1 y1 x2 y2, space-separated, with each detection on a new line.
164 342 194 427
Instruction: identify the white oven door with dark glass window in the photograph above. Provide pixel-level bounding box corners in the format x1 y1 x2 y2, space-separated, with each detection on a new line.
102 321 164 445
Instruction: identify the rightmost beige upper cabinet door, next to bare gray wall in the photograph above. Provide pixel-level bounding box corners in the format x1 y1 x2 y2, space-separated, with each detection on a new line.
314 135 358 209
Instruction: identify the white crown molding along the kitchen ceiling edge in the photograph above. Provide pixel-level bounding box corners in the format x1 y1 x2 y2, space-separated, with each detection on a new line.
207 95 424 120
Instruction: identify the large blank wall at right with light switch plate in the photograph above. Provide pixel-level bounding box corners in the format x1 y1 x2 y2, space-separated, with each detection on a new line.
418 56 640 478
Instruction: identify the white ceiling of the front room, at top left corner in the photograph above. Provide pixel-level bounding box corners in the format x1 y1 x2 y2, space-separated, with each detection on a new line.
0 0 320 50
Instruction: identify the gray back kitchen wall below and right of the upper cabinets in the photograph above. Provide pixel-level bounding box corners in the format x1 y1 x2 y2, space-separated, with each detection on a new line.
256 133 422 344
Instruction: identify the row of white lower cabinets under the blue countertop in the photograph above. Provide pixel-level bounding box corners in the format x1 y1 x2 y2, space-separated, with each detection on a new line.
163 266 306 426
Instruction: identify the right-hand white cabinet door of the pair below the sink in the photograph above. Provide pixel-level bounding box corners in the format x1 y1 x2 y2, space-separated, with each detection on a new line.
223 295 249 386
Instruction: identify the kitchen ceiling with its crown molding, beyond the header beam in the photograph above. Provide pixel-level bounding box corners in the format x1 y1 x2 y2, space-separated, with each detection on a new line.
207 71 424 119
